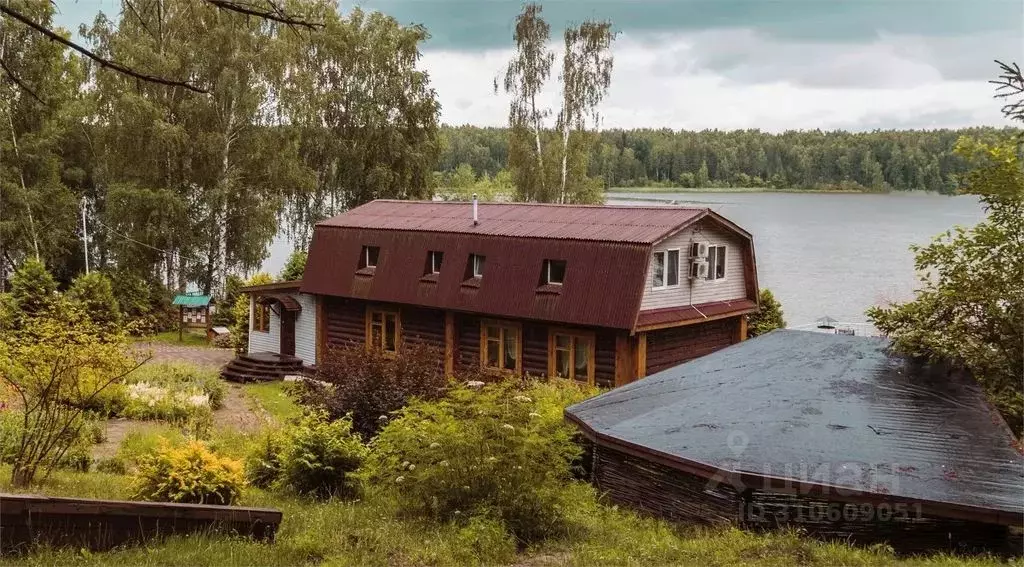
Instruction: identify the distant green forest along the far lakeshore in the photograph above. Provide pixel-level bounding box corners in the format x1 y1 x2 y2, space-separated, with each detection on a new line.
437 126 1013 192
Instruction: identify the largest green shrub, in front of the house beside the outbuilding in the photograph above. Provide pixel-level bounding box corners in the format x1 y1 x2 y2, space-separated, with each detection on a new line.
362 381 595 542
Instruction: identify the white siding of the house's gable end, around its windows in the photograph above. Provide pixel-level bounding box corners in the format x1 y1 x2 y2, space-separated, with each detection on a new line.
640 220 746 311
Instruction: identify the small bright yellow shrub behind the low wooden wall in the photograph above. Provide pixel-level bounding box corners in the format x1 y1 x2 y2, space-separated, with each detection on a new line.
132 435 245 505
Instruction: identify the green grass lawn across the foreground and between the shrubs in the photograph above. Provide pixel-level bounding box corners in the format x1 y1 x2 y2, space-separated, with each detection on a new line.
0 370 1005 567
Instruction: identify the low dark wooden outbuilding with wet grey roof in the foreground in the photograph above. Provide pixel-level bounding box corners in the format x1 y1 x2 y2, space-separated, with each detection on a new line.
565 330 1024 554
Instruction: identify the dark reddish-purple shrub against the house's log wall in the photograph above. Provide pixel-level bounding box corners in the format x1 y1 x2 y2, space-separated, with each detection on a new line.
298 344 447 439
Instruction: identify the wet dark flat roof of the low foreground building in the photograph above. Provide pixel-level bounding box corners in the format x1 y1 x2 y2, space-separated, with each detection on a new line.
566 331 1024 525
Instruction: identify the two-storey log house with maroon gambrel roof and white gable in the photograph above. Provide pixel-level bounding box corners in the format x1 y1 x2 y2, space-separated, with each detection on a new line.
220 201 758 387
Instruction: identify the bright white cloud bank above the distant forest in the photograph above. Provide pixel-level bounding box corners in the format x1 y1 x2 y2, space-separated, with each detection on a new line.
423 30 1012 131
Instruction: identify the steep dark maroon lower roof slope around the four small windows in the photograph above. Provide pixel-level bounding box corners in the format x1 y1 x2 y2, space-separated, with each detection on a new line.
302 226 650 329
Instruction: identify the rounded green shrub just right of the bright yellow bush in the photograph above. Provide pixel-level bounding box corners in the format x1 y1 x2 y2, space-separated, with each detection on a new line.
246 411 367 498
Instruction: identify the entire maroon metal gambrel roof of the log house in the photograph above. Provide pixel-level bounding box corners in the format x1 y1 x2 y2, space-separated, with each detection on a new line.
301 201 757 330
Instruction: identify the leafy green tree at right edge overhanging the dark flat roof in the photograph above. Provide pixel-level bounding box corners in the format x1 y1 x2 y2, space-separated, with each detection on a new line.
867 135 1024 434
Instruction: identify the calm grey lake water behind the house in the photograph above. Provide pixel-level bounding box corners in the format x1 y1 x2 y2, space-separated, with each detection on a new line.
263 192 984 326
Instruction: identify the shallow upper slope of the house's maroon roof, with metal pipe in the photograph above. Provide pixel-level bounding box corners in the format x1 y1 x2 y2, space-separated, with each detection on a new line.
318 200 709 244
